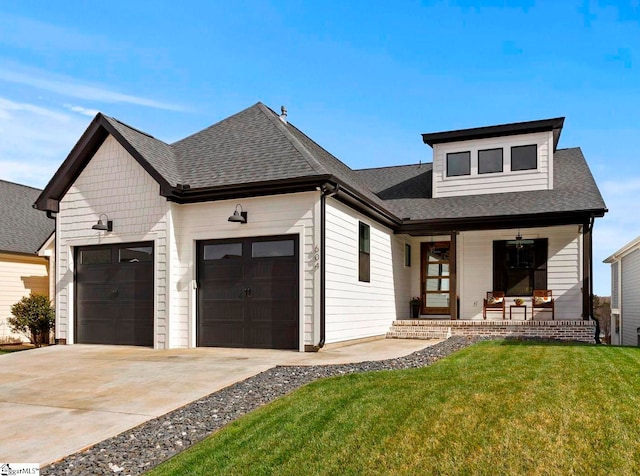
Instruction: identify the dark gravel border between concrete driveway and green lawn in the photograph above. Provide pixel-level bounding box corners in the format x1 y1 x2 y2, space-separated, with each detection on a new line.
40 336 486 476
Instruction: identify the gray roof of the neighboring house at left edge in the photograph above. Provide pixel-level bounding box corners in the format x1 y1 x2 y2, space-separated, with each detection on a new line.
0 180 55 254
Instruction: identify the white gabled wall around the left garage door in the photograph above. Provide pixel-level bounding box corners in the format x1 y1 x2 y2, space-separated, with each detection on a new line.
56 136 170 348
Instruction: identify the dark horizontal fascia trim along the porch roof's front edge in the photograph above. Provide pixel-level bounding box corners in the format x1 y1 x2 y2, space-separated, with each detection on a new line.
396 209 606 236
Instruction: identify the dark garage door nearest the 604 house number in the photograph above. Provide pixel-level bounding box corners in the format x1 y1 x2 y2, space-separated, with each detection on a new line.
197 235 299 349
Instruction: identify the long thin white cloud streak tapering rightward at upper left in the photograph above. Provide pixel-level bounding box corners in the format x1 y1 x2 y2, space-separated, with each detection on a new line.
0 61 184 111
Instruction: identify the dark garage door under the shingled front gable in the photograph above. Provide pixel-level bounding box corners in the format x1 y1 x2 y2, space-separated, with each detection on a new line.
76 242 153 346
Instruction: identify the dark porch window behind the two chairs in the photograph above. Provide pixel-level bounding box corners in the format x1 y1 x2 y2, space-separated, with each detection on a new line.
493 238 548 296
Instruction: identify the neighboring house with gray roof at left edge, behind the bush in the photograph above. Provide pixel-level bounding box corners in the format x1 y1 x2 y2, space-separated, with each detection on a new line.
0 180 54 342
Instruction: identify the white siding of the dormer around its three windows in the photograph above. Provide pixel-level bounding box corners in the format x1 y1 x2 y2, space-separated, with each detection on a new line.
433 132 553 198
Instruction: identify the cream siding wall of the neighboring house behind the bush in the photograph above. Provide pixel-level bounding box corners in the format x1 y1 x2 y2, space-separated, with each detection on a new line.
0 253 49 342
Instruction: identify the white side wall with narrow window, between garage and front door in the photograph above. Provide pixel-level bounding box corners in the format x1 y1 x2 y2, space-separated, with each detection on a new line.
325 198 416 344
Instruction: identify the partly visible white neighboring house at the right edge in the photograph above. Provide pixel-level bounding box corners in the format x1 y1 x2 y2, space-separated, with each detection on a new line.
604 237 640 346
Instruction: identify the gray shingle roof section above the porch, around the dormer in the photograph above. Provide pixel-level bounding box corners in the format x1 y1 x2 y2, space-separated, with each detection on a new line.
360 147 606 220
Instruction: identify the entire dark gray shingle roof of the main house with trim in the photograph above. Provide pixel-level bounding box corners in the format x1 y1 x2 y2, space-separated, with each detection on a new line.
35 103 606 229
